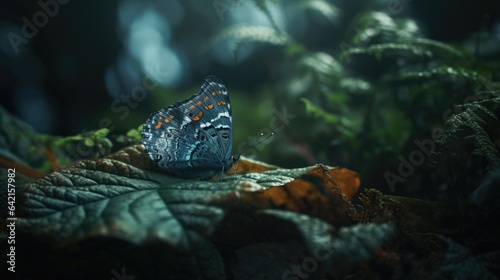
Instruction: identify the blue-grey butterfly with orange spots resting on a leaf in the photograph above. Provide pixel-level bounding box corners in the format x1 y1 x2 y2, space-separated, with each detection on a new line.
141 76 240 180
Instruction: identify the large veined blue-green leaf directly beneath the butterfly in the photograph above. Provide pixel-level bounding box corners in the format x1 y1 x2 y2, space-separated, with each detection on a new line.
18 145 352 252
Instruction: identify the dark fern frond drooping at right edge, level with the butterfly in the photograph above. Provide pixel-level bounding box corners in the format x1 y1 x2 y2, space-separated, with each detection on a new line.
438 97 500 168
